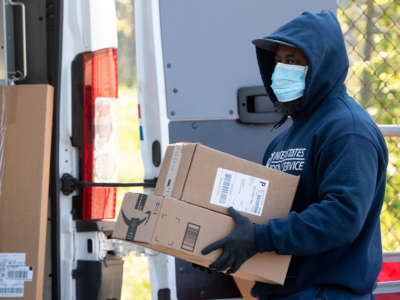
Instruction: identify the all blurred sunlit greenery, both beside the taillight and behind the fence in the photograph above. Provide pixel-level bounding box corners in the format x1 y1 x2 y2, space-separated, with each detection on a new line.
116 0 400 300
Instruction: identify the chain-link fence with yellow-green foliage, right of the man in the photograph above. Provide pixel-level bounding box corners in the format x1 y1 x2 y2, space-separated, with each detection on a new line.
337 0 400 251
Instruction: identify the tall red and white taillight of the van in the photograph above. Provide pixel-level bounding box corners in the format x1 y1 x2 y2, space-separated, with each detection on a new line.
82 48 118 220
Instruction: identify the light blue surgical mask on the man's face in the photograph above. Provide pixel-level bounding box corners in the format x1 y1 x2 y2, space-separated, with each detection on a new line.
271 63 308 102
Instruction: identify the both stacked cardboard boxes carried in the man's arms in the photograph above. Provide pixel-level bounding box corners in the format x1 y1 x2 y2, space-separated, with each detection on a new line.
114 143 298 284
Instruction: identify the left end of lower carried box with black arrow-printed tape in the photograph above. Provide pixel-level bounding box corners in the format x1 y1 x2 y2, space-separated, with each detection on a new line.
113 193 163 243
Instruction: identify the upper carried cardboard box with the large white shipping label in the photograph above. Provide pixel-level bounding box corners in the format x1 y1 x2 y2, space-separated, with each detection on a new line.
155 143 299 224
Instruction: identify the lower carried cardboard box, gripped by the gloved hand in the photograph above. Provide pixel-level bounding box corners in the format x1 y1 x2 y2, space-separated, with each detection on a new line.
113 193 290 284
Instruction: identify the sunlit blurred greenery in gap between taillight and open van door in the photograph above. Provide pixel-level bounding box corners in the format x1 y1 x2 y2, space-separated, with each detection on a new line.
116 0 151 300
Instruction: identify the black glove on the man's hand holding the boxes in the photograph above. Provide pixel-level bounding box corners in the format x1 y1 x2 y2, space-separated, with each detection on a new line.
201 207 258 274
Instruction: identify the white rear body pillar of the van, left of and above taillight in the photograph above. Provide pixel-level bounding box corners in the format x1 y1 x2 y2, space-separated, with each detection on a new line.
59 0 118 300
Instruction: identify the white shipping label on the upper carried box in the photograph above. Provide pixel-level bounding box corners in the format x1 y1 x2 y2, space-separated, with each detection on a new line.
210 168 269 216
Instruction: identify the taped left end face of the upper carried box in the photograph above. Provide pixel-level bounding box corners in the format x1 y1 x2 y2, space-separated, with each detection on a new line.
154 143 197 199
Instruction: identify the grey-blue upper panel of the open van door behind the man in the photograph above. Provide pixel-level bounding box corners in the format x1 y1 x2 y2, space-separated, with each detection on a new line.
159 0 337 121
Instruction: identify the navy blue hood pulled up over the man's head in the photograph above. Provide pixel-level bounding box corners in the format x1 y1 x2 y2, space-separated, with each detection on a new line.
253 11 349 115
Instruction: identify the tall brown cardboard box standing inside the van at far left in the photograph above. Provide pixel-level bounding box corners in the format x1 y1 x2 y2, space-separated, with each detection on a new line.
0 84 53 300
